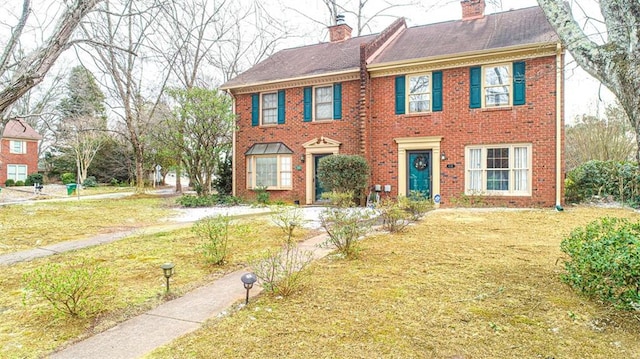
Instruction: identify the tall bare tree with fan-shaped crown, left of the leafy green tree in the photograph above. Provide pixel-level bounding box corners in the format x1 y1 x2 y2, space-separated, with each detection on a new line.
82 0 173 192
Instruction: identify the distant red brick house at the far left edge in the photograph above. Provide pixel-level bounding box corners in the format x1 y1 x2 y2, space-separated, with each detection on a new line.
0 119 42 186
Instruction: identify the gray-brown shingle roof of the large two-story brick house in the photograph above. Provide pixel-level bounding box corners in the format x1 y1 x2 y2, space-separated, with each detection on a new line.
221 6 558 88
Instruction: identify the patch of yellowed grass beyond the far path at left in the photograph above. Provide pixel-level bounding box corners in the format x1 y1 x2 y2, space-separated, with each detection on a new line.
0 196 174 254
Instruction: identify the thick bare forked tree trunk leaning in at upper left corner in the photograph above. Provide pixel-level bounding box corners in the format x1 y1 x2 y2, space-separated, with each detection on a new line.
0 0 104 117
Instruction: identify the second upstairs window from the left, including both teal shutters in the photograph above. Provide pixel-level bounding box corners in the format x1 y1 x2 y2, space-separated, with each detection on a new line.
303 83 342 122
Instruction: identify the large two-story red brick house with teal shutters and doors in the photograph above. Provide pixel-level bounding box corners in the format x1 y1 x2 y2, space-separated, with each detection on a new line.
221 0 564 206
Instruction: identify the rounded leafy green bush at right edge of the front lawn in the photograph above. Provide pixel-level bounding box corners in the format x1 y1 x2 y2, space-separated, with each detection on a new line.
560 218 640 311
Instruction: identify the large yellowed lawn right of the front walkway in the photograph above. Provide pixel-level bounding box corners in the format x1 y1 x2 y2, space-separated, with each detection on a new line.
150 208 640 359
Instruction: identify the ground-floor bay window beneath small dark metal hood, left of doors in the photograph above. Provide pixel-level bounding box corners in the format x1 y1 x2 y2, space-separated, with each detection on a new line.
247 154 293 190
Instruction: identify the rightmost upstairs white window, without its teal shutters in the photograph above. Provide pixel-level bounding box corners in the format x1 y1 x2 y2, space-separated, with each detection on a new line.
482 62 513 108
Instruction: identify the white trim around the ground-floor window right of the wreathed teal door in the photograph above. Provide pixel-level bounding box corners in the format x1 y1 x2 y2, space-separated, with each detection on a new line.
464 143 533 197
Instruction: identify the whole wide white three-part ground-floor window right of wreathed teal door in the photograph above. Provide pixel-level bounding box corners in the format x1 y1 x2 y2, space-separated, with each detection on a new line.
465 144 532 196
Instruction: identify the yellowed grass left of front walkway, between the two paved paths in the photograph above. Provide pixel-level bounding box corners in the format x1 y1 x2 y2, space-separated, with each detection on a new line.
0 214 310 358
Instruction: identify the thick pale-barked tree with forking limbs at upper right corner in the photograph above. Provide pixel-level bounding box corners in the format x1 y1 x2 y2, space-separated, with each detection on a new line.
538 0 640 161
